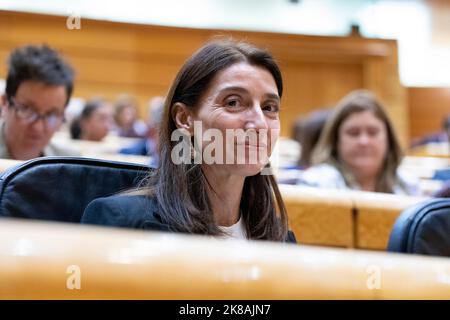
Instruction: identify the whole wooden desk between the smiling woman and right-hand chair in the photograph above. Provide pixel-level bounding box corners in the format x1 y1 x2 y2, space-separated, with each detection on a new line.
280 185 427 250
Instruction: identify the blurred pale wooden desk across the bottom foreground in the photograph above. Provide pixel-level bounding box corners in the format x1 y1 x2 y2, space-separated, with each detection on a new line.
0 220 450 300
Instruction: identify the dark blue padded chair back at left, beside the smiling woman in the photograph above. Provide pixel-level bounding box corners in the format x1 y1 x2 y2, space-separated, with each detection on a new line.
0 157 149 223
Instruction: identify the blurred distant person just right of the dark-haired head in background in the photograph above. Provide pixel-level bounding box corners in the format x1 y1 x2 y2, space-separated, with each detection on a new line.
114 95 147 138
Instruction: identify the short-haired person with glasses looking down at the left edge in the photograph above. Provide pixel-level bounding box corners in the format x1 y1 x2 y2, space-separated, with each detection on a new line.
0 46 78 160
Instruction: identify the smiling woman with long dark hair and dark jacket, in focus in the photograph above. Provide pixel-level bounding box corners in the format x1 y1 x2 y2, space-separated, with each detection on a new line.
82 41 295 242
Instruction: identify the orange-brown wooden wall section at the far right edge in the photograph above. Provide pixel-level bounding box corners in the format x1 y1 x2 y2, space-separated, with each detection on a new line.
408 87 450 139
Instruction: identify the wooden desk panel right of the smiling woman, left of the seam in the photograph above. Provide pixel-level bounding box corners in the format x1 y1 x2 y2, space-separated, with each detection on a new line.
280 185 354 248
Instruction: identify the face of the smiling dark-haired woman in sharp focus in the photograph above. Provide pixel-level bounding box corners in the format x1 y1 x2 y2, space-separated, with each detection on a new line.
193 62 280 176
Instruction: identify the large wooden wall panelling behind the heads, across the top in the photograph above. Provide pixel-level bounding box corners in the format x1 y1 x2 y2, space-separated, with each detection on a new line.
0 11 408 143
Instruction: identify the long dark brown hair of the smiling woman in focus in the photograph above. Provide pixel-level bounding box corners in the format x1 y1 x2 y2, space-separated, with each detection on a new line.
138 40 287 241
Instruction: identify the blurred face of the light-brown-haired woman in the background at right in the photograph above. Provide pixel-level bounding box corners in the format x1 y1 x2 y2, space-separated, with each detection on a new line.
338 111 388 177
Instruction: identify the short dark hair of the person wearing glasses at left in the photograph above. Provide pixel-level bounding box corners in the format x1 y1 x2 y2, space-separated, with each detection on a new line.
5 45 74 105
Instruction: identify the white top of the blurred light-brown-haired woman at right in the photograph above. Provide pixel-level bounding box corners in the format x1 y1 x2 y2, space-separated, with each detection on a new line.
297 164 421 196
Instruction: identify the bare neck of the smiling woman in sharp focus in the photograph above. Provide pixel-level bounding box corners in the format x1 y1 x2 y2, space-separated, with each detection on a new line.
203 167 245 227
